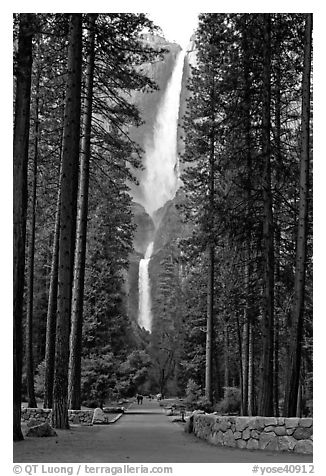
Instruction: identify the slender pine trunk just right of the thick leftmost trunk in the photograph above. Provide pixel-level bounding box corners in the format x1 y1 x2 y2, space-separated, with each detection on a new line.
26 70 40 408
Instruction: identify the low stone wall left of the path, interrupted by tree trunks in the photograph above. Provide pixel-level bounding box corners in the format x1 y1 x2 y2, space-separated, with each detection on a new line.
21 408 94 426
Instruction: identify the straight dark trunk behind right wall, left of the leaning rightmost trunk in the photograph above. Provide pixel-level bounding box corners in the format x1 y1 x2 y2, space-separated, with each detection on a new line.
258 13 274 416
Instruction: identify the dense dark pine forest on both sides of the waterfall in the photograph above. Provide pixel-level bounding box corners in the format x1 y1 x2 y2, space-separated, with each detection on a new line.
13 13 313 440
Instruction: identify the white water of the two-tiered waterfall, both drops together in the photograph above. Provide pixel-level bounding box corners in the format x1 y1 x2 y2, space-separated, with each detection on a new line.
138 50 185 332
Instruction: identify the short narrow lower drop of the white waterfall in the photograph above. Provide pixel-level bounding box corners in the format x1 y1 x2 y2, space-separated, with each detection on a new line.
138 241 154 332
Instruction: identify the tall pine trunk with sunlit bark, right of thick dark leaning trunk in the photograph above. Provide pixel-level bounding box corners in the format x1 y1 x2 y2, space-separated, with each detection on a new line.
68 14 96 410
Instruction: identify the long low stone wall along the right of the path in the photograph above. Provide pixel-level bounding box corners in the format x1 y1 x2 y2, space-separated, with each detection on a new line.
193 413 313 454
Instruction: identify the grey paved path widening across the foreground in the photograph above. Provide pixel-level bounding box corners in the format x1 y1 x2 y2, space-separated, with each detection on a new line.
14 400 312 464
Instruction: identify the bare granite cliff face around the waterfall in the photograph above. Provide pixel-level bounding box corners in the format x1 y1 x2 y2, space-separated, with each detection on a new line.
126 36 190 338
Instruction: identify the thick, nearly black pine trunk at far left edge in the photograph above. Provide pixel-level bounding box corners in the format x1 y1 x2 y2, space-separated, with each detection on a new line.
13 13 34 441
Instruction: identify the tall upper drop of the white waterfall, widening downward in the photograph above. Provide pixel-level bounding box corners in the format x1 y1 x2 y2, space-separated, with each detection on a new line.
141 50 186 216
